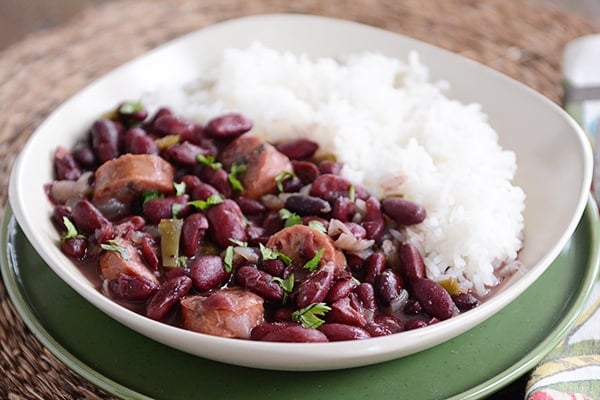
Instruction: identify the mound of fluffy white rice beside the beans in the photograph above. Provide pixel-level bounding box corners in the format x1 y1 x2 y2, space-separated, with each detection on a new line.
145 44 525 295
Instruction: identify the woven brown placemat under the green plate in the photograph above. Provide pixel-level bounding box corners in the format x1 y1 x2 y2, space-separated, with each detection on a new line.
0 0 600 400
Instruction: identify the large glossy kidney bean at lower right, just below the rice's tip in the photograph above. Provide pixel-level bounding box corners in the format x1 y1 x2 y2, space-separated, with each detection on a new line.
411 278 458 320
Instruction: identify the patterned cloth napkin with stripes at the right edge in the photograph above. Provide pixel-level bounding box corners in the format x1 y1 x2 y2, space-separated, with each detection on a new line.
526 35 600 400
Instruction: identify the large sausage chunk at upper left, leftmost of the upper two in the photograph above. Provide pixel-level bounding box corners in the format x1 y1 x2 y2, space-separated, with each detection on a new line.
92 154 175 214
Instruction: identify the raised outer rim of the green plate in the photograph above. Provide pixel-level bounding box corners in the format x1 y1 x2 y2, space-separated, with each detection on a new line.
0 200 600 400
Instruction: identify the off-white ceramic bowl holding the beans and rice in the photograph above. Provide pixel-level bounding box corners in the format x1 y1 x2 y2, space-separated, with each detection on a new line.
9 15 592 370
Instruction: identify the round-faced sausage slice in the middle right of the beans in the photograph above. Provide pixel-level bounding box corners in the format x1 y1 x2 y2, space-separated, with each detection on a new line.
266 225 346 271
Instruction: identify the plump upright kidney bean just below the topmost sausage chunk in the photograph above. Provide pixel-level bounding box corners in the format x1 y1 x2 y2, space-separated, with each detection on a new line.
205 199 248 247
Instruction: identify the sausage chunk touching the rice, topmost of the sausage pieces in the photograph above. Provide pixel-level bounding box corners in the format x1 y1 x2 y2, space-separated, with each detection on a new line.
219 136 293 199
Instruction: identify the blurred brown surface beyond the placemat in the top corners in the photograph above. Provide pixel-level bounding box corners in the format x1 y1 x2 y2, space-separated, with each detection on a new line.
0 0 600 50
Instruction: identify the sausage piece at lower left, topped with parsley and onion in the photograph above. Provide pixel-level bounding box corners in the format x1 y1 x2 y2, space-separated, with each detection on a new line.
99 239 159 285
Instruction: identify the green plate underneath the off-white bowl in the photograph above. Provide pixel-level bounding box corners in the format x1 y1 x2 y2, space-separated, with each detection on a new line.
0 200 600 400
